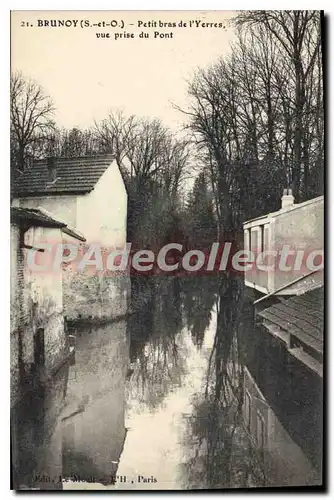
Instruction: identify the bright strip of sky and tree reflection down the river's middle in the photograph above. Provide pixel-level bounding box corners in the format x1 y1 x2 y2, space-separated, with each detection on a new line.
109 280 216 490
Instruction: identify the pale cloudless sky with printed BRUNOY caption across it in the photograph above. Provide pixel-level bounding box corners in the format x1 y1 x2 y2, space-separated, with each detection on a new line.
11 11 234 134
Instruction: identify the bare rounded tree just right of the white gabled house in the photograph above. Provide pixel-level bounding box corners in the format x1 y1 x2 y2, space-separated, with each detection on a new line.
95 111 189 246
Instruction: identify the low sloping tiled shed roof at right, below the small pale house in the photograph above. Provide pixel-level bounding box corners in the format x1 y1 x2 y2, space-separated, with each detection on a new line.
257 286 324 357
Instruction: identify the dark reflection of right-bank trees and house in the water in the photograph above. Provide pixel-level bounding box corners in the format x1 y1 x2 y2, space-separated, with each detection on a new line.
184 281 322 489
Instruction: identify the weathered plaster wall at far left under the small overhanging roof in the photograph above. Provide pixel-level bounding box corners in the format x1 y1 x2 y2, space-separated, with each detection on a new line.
11 226 69 403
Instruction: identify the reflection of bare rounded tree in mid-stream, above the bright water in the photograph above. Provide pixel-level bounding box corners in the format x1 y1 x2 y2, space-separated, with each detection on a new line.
129 277 184 409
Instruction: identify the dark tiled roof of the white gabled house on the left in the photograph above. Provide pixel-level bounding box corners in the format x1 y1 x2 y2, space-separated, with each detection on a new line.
13 155 113 197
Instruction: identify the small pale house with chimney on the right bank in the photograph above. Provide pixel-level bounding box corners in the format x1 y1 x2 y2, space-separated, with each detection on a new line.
243 190 324 295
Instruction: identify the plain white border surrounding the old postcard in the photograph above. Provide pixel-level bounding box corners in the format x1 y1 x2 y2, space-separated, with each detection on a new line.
0 0 334 498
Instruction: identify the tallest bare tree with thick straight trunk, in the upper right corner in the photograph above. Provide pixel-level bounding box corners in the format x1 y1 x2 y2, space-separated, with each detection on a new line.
236 10 323 199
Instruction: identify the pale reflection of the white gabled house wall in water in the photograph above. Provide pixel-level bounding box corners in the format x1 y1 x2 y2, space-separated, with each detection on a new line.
62 321 129 484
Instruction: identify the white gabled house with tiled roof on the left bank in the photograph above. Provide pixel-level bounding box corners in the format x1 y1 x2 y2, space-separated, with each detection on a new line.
13 155 128 319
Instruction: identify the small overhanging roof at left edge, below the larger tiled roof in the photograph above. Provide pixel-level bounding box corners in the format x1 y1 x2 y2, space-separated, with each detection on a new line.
10 207 86 241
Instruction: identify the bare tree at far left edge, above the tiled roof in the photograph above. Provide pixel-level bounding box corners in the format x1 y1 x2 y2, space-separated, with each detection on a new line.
10 73 54 176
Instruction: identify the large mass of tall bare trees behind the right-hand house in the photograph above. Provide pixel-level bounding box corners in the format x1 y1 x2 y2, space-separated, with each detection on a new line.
181 11 324 237
